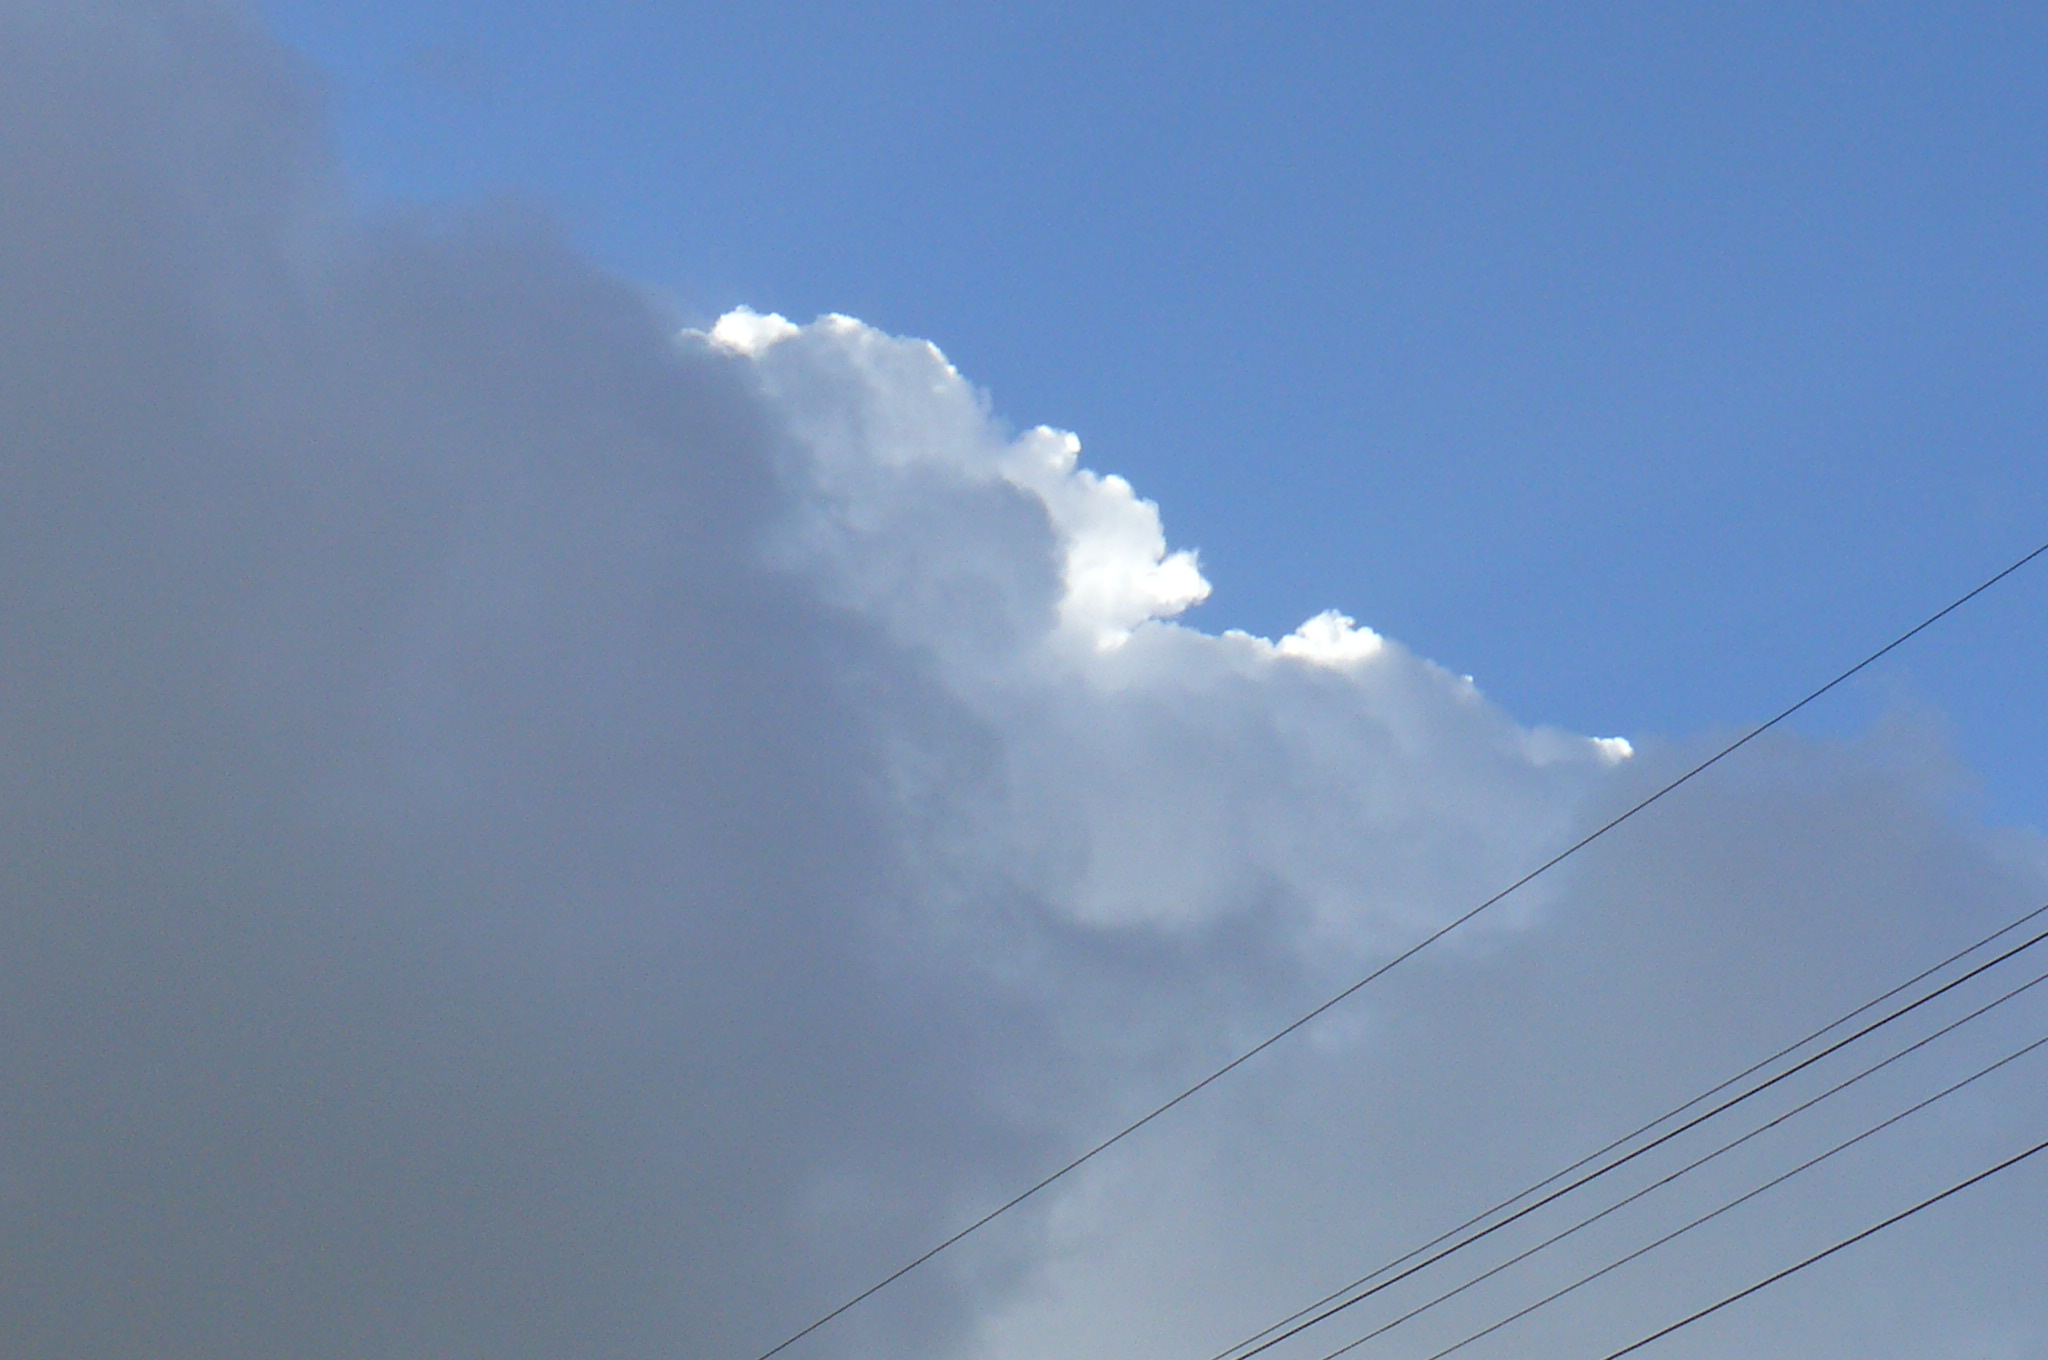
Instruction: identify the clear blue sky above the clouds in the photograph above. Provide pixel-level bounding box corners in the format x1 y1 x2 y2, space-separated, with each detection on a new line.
266 0 2048 825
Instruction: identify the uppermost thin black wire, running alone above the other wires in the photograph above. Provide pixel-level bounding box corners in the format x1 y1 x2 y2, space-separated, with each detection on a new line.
756 543 2048 1360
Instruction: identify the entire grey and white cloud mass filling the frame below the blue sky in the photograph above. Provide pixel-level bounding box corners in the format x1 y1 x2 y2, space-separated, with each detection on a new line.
0 0 2048 1360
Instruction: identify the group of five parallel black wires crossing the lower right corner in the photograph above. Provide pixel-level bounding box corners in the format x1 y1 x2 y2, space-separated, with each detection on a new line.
1190 905 2048 1360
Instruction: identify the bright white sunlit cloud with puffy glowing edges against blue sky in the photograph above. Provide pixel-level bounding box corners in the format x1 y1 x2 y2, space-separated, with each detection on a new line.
713 311 1616 950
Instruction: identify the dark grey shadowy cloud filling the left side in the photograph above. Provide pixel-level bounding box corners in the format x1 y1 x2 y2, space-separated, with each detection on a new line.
0 4 1040 1356
